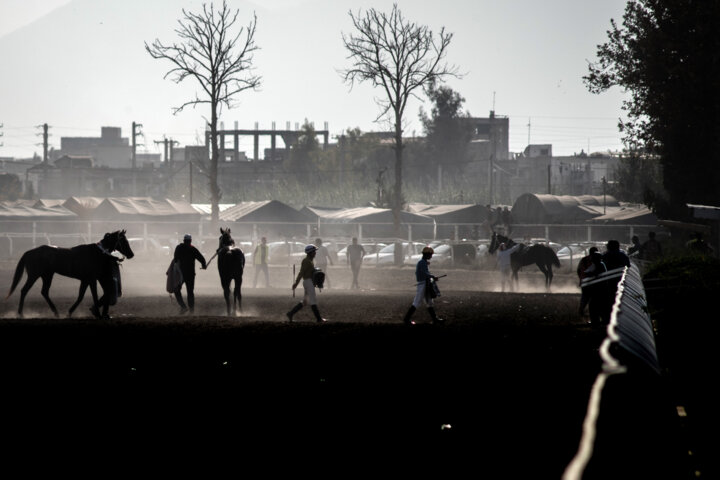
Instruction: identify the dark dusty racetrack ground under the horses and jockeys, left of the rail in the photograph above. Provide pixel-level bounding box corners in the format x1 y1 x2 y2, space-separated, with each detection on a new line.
0 258 624 478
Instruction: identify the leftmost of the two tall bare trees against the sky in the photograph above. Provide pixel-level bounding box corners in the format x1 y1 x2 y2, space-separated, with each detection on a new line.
145 0 261 224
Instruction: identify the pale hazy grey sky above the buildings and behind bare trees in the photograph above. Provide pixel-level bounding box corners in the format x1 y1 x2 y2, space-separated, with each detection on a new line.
0 0 626 158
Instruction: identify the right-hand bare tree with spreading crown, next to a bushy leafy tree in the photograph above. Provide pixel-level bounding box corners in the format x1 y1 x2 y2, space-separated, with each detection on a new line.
342 4 460 236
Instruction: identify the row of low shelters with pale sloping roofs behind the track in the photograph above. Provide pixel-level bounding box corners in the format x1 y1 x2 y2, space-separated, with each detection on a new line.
0 194 658 251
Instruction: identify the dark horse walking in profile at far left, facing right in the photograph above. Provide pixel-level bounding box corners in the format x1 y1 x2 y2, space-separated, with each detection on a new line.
7 230 135 318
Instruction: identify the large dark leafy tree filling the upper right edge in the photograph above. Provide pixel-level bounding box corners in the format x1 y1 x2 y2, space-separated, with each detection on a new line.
584 0 720 218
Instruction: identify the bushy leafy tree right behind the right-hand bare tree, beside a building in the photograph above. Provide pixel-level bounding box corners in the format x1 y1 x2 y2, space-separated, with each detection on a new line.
420 82 472 174
